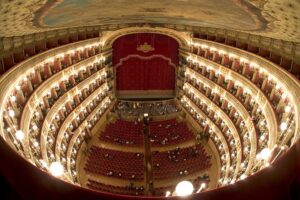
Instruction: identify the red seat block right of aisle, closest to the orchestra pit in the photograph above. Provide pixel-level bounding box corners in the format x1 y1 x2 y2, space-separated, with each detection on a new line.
150 119 194 146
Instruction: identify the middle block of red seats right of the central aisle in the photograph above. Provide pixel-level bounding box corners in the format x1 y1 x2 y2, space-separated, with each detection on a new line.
152 144 211 180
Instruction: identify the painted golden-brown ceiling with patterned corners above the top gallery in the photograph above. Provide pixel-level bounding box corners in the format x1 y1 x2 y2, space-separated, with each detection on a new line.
0 0 300 42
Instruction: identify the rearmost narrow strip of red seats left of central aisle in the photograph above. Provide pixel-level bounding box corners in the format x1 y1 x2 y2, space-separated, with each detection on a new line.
87 179 144 196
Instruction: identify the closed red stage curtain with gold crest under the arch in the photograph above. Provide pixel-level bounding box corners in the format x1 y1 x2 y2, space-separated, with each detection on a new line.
113 33 178 91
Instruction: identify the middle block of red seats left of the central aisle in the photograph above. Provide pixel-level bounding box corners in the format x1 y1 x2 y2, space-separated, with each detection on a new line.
84 146 144 181
